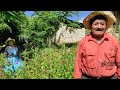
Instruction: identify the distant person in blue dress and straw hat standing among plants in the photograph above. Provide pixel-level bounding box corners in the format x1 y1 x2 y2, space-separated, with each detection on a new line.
4 38 22 72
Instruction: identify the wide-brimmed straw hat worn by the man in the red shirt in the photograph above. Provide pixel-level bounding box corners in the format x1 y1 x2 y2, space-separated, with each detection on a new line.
83 11 116 29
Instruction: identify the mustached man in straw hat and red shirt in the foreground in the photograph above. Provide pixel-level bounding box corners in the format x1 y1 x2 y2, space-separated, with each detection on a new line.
73 11 120 79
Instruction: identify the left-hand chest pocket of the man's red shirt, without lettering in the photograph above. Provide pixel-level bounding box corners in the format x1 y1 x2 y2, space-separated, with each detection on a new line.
84 51 95 69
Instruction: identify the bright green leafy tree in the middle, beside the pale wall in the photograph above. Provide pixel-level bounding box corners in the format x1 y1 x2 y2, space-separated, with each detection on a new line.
19 11 79 48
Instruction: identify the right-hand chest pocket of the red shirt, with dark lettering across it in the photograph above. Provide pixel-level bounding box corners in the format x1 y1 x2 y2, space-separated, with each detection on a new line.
104 49 116 70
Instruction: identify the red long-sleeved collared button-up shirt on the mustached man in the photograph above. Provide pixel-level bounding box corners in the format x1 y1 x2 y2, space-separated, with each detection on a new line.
73 33 120 78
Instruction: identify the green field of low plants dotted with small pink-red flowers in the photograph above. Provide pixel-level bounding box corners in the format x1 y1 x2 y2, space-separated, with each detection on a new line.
0 44 77 79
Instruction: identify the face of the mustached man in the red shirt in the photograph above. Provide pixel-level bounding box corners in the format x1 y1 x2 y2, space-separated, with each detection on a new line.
91 19 106 37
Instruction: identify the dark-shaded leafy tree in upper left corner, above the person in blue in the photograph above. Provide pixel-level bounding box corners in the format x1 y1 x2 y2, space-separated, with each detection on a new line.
0 11 26 45
